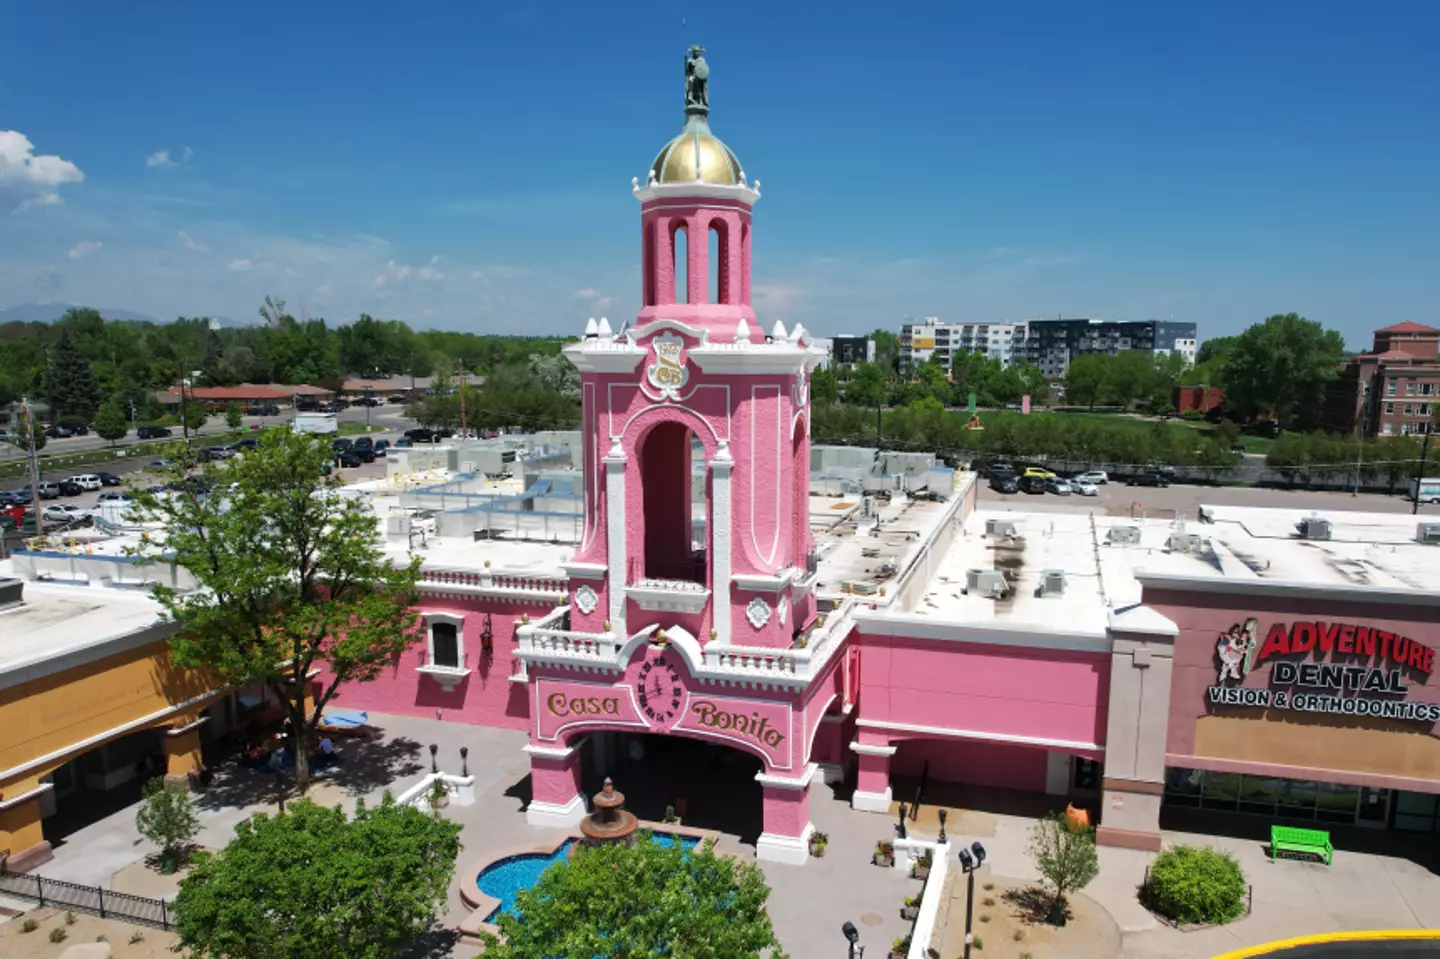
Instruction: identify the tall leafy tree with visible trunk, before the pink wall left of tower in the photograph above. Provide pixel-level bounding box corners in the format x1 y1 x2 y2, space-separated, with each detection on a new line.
127 431 420 789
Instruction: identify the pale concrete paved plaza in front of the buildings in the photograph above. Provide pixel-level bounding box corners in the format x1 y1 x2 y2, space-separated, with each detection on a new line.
8 705 1440 959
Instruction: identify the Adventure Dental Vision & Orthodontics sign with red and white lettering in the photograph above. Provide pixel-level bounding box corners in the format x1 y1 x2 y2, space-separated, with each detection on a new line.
1207 618 1440 723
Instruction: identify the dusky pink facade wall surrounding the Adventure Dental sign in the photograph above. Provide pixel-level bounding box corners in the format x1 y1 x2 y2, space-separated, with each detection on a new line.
1145 589 1440 756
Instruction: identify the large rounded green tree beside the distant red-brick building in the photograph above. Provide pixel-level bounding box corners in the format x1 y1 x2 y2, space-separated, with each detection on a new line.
1224 312 1345 423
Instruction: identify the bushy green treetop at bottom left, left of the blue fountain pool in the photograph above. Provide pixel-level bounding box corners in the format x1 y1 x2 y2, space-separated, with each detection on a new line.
174 792 460 959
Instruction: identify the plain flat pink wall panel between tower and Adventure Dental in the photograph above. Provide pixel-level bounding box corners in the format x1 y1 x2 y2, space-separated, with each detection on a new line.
860 635 1110 744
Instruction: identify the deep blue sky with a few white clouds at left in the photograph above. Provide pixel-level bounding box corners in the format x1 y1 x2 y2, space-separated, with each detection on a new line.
0 0 1440 346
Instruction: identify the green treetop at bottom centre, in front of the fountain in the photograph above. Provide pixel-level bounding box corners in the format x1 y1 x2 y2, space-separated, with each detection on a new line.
485 834 785 959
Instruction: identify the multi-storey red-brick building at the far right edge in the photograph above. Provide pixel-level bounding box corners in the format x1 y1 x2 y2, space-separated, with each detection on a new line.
1323 321 1440 436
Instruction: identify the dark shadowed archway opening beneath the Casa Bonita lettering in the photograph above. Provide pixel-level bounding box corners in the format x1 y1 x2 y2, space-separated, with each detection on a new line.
582 733 765 845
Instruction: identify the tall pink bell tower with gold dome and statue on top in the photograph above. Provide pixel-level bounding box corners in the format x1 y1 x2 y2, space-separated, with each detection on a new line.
517 48 851 864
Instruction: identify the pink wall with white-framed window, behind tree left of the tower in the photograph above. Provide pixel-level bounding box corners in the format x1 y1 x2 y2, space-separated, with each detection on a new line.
321 596 550 729
